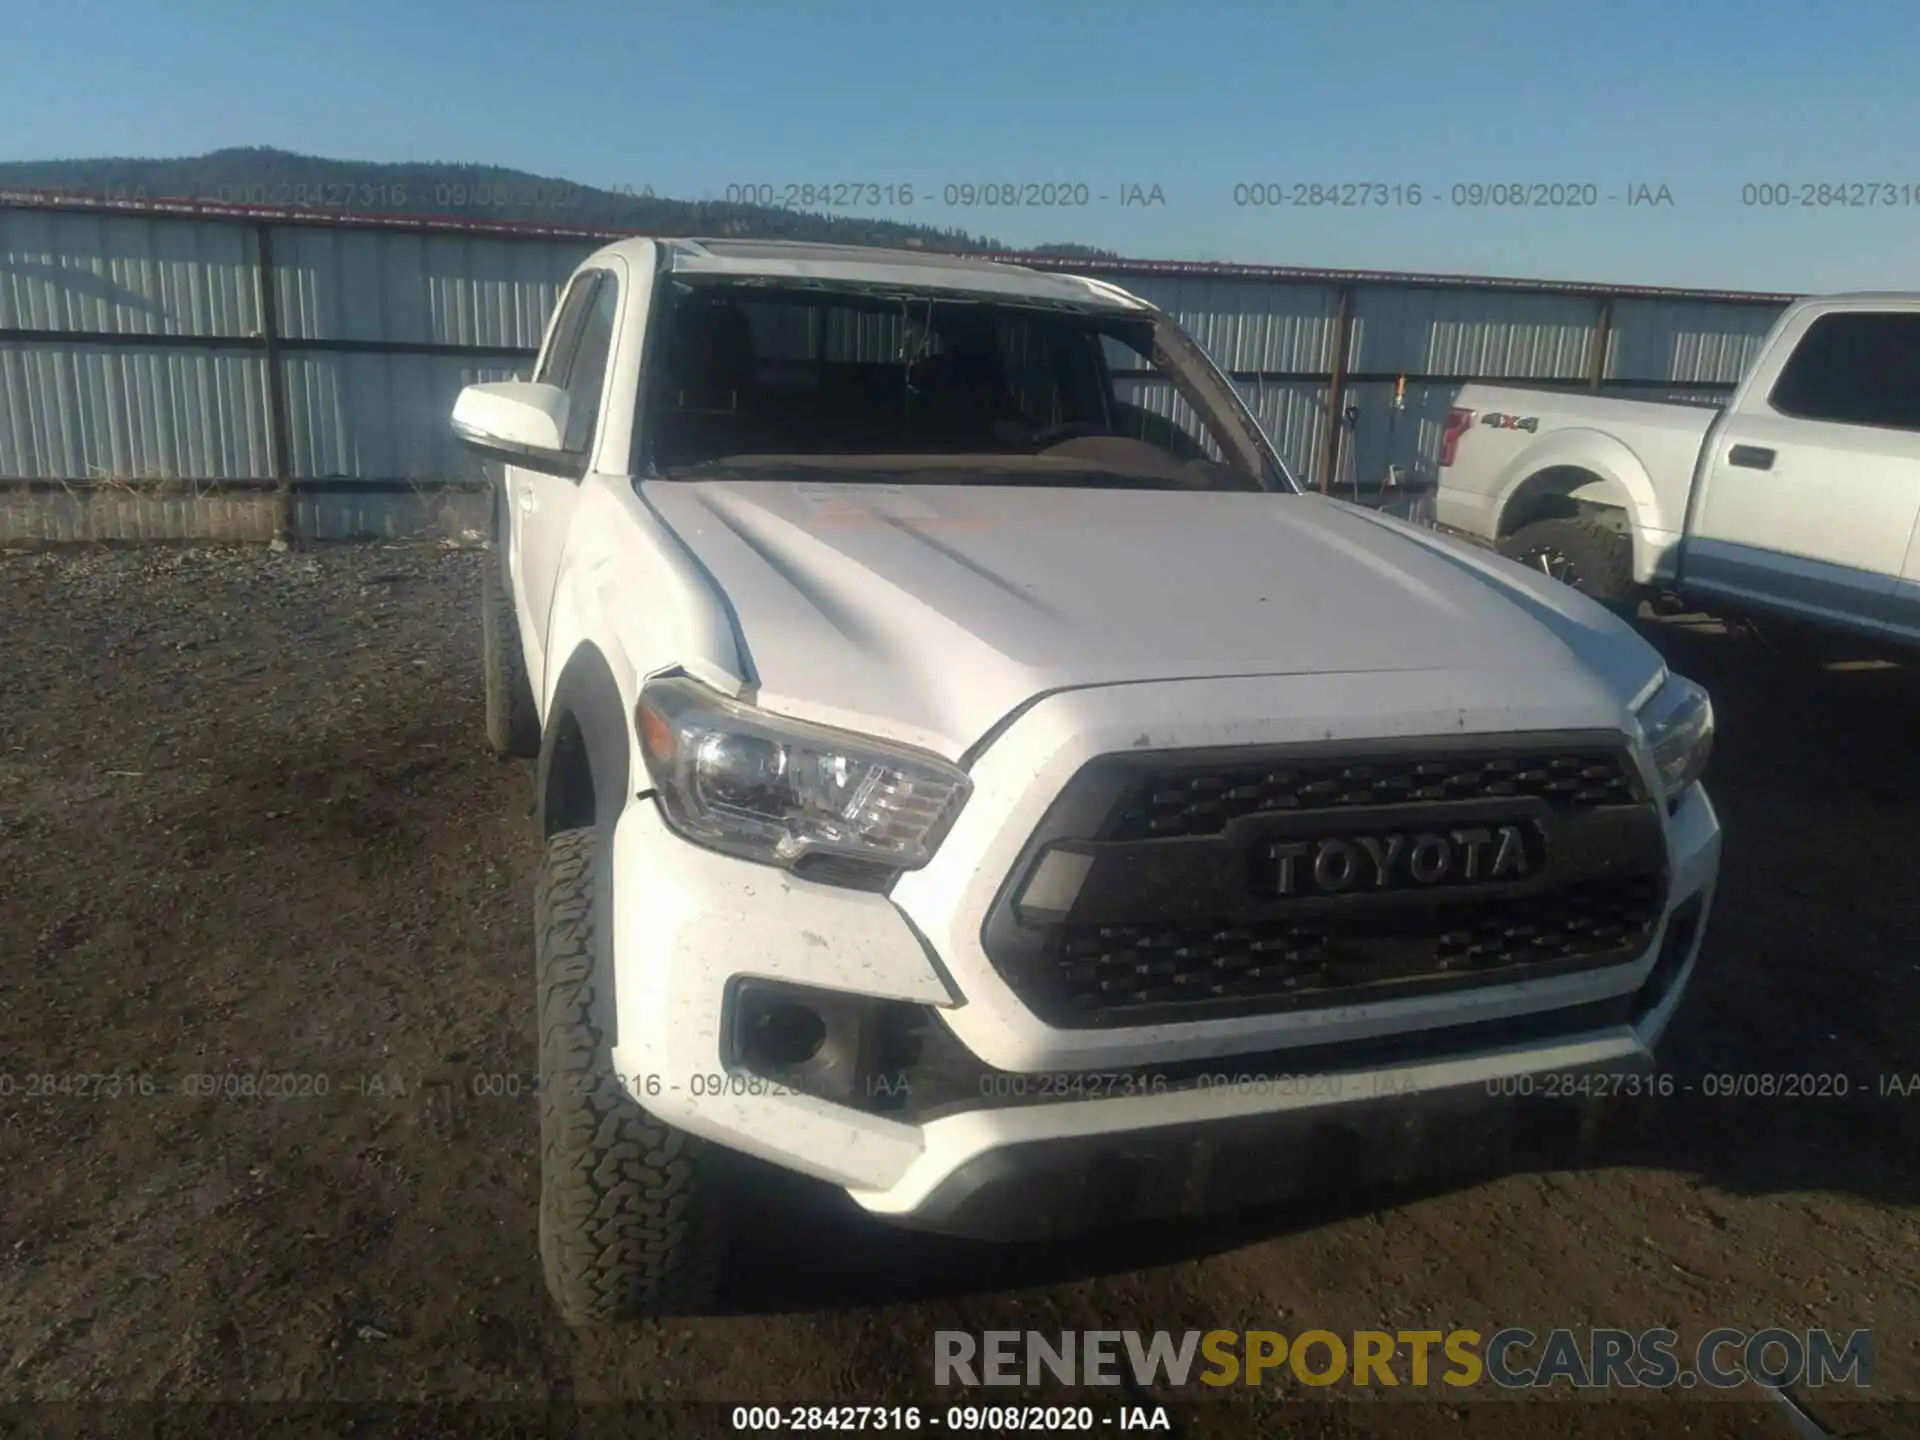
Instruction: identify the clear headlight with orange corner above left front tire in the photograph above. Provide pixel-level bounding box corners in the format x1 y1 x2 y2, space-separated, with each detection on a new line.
634 678 972 885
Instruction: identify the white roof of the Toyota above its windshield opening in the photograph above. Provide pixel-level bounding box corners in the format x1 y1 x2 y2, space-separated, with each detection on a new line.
576 236 1148 311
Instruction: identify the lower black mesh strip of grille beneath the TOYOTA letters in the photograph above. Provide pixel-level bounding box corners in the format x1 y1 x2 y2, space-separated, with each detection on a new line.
1046 879 1661 1012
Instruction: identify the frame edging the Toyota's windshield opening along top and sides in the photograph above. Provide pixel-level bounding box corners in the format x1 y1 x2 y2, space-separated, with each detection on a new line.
630 267 1300 493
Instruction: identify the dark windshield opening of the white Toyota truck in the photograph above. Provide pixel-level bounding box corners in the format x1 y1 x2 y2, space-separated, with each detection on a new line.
641 282 1292 490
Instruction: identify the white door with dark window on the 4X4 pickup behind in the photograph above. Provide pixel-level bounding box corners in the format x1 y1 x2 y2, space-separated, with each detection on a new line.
1682 309 1920 630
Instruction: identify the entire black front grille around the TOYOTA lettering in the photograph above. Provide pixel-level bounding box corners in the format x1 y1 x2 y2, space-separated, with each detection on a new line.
981 732 1668 1027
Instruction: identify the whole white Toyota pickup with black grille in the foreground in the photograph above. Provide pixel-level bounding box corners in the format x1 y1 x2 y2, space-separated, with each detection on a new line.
453 240 1720 1323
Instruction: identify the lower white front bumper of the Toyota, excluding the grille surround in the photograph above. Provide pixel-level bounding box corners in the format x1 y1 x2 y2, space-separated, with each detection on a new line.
614 771 1720 1238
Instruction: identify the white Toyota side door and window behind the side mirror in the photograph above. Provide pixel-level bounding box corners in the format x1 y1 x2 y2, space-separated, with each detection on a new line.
507 271 620 695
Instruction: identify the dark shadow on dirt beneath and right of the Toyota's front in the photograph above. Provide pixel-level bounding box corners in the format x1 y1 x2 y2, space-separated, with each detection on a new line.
718 618 1920 1313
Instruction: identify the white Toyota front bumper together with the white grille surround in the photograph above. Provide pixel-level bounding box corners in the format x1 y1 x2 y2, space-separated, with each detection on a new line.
612 670 1720 1235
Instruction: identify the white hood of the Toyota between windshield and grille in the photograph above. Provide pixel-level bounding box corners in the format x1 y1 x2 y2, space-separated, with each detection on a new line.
639 478 1661 758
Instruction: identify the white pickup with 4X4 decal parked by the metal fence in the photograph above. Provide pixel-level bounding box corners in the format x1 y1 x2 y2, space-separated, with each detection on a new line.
1434 294 1920 645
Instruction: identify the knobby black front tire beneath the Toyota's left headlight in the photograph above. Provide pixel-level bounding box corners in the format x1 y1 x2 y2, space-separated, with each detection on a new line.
534 829 728 1327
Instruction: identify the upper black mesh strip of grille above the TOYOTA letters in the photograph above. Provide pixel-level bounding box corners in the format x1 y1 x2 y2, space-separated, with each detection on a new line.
1110 751 1636 839
